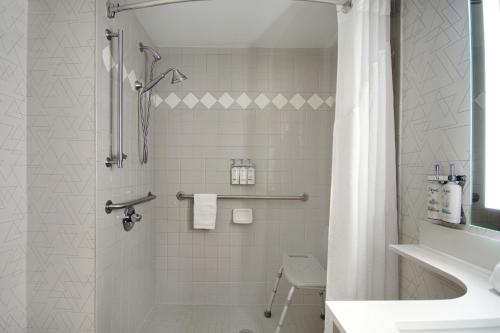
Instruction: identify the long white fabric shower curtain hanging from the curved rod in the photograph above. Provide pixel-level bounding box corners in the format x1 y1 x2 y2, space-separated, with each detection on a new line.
327 0 398 300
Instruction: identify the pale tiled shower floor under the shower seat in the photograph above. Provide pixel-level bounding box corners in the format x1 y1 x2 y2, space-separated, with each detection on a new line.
140 305 324 333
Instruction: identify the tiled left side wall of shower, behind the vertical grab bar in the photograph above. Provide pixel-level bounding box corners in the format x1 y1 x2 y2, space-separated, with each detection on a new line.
96 6 154 333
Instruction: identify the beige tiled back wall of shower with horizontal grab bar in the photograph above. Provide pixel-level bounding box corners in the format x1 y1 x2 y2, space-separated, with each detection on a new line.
149 48 336 305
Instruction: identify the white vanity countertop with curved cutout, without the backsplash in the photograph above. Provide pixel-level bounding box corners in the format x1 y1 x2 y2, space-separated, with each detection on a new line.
327 245 500 333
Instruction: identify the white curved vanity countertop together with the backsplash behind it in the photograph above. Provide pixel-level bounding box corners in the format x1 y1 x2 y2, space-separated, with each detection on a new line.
327 223 500 333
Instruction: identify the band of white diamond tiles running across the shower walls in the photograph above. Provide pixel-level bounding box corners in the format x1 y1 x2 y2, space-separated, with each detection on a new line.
102 50 335 110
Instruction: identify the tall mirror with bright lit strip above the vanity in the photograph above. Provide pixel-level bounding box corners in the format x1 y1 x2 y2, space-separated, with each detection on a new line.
470 0 500 231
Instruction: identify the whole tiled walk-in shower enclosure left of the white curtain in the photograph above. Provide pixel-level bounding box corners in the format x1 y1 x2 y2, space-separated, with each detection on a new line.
96 0 336 333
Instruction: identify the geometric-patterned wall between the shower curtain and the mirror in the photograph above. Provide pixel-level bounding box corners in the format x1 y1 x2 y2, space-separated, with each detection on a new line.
399 0 498 299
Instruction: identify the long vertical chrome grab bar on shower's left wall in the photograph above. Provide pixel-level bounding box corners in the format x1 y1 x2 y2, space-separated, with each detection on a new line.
105 29 127 168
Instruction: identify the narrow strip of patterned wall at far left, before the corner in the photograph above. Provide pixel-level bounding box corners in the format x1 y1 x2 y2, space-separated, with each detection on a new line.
0 0 28 333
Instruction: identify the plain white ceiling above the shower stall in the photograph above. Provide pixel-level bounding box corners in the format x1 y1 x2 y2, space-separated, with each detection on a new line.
131 0 337 48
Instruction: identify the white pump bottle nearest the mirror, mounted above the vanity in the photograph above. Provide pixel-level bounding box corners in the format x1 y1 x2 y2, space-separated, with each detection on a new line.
441 164 462 224
